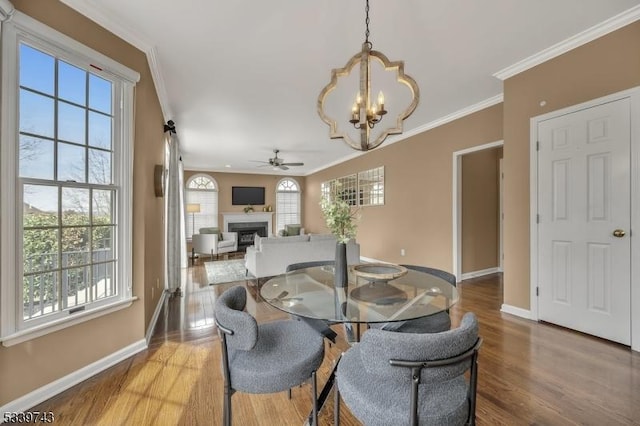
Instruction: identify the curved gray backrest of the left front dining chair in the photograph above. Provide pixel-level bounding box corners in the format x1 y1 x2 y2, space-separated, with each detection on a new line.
213 285 258 351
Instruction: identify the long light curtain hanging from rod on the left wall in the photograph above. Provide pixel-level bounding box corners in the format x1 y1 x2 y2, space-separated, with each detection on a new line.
165 131 188 292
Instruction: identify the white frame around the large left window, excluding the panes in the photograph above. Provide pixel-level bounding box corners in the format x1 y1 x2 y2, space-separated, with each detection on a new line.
0 11 140 346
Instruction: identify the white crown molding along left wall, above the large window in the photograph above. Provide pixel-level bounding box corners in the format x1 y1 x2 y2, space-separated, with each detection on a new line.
60 0 173 121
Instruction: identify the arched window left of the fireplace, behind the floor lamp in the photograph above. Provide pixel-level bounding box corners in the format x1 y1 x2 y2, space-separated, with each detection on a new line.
185 174 218 235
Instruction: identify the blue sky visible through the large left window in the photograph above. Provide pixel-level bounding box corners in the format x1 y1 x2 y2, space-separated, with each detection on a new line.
18 43 113 212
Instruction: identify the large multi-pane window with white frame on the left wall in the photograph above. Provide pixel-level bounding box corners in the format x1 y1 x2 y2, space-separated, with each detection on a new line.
0 12 139 344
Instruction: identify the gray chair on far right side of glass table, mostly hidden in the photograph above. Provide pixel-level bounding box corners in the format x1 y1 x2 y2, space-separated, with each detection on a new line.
370 265 456 333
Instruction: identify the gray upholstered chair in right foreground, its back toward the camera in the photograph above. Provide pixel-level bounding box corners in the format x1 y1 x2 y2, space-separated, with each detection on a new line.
335 313 482 426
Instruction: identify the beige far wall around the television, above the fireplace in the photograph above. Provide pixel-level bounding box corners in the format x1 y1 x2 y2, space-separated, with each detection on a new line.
184 170 306 234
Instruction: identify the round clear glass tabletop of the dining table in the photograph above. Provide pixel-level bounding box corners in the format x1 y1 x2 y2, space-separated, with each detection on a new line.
260 266 458 323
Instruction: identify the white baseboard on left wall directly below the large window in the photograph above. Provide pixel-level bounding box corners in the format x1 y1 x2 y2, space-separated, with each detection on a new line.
0 339 147 413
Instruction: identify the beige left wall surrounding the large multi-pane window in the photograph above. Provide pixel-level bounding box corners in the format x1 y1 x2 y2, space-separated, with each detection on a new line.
0 0 163 406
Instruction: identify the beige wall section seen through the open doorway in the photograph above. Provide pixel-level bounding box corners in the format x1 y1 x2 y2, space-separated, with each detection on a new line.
461 148 502 273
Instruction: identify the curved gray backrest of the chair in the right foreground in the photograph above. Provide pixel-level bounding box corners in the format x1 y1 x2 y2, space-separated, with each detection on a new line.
359 312 478 383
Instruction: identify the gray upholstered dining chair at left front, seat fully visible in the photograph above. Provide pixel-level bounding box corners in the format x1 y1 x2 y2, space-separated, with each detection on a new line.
214 286 324 426
